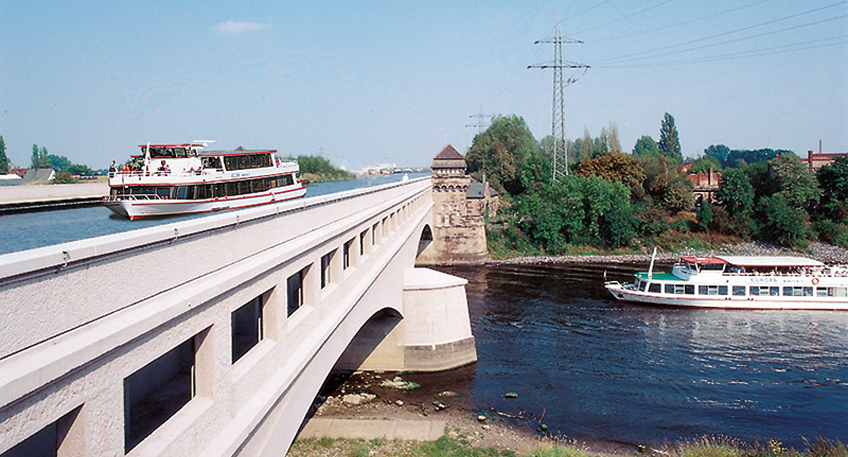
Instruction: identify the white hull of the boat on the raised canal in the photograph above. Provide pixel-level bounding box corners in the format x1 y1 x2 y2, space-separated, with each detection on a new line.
103 186 306 220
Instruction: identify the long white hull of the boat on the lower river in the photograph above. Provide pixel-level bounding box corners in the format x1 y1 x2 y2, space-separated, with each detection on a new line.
604 281 848 311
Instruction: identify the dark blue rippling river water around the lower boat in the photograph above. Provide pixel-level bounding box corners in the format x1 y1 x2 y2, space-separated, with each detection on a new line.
443 264 848 447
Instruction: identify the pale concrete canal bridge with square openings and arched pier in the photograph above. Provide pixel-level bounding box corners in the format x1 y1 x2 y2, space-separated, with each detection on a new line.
0 177 476 457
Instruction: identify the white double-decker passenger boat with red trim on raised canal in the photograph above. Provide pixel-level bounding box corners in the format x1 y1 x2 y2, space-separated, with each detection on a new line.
103 142 306 220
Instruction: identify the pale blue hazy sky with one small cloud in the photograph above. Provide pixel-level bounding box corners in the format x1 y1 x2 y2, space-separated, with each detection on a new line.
0 0 848 169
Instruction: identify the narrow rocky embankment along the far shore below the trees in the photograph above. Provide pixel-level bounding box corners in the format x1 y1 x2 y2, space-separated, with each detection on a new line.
487 241 848 265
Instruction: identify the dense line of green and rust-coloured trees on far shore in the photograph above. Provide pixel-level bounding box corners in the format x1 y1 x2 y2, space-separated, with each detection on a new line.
466 113 848 256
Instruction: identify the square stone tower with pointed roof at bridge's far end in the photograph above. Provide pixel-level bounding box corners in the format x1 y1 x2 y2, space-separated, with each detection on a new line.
416 144 498 265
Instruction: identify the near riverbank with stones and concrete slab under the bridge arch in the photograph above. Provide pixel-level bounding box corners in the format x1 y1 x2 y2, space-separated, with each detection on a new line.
287 366 636 457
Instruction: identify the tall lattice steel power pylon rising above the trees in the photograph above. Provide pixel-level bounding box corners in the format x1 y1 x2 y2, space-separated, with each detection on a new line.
527 22 589 181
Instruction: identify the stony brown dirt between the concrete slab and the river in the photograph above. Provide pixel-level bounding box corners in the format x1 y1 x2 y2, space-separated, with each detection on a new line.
310 369 653 457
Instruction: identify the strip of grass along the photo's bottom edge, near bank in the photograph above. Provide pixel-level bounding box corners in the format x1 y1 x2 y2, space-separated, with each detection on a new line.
288 433 848 457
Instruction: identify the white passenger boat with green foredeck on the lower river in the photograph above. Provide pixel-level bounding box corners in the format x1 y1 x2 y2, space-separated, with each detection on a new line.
605 249 848 310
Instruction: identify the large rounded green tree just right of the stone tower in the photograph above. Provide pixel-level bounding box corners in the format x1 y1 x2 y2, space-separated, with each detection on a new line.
465 115 550 196
